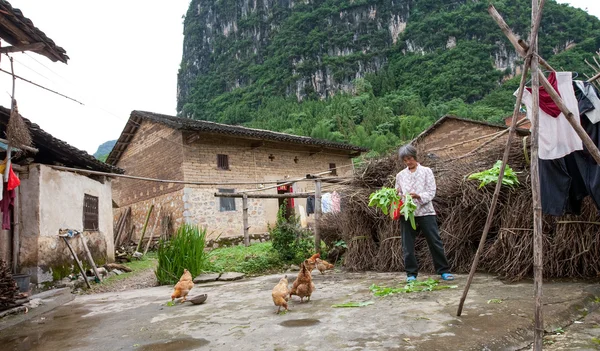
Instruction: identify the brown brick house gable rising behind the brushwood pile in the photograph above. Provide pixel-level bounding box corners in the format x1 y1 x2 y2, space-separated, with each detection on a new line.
413 115 529 159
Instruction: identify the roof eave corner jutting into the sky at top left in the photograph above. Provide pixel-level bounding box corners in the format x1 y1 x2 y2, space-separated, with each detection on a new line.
0 0 69 63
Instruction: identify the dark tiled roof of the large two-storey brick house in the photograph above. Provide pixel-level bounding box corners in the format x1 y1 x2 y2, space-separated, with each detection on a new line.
106 111 368 165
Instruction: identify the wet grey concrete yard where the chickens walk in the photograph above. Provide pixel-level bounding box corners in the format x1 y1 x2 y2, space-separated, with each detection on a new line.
0 271 600 351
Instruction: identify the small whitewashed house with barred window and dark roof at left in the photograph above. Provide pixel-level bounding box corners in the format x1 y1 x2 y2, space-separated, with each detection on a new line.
0 106 123 284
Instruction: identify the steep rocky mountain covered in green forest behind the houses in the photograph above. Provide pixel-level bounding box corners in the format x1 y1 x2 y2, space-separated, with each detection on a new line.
177 0 600 152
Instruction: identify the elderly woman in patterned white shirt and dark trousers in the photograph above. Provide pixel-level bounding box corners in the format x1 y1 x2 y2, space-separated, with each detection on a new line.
396 144 454 282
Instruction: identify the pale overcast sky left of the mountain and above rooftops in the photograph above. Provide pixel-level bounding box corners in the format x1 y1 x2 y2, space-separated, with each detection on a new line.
0 0 600 153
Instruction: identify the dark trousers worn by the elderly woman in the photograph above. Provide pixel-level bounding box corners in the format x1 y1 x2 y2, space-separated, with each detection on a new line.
400 215 450 277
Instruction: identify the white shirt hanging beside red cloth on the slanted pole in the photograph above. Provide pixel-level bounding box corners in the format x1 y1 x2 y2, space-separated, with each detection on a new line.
514 72 583 160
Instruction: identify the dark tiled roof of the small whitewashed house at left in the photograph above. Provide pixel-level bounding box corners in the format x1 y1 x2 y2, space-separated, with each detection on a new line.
0 106 125 174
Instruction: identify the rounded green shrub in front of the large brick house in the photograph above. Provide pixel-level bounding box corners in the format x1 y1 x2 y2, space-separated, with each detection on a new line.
269 203 315 264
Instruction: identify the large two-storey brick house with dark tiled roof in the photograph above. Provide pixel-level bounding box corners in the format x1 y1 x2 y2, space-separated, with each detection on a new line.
106 111 366 238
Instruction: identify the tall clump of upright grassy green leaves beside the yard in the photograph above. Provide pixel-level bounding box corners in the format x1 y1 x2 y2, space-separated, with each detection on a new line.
155 224 208 285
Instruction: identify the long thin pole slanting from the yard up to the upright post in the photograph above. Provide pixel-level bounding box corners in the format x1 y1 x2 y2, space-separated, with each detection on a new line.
456 60 531 317
